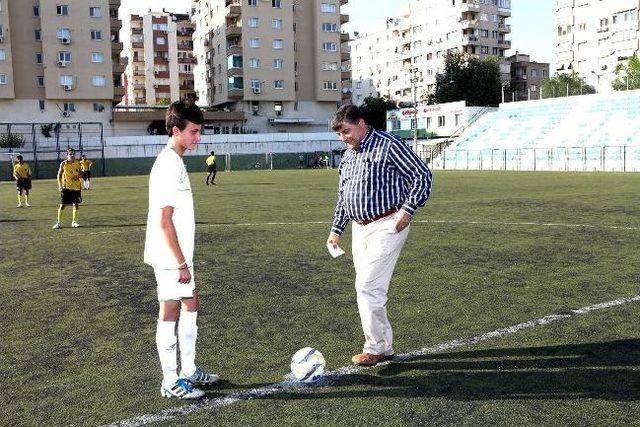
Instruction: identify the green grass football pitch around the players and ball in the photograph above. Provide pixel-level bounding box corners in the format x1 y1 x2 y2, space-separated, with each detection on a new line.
0 170 640 426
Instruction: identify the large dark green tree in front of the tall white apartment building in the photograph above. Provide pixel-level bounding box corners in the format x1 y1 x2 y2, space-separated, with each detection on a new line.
428 51 502 106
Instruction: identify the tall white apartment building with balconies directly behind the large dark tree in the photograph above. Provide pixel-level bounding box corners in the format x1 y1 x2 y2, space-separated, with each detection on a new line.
412 0 511 98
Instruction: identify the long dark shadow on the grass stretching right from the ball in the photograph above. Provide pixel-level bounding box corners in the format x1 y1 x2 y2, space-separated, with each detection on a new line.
268 340 640 401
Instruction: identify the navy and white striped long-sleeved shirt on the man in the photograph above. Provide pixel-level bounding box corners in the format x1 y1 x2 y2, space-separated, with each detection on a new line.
331 128 432 235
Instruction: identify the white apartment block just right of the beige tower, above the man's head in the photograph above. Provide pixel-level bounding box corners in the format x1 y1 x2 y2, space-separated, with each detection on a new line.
351 15 412 105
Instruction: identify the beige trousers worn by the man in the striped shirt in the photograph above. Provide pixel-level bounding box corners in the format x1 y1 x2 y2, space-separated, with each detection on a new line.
352 215 409 355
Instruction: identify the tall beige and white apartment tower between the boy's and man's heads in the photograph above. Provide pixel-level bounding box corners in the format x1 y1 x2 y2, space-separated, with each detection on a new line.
192 0 351 132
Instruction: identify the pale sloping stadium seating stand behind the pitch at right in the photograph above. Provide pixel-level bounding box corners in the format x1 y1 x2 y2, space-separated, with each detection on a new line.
434 90 640 171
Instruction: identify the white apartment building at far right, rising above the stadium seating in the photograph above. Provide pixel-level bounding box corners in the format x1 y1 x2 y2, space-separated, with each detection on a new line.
555 0 640 92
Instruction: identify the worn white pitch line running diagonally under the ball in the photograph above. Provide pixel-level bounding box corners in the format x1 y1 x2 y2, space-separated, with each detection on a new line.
102 295 640 427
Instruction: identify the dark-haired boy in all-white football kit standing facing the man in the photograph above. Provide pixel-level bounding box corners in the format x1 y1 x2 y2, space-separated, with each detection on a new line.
144 101 219 399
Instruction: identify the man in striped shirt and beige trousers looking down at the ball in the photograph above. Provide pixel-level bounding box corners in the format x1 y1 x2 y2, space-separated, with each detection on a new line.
327 105 432 366
